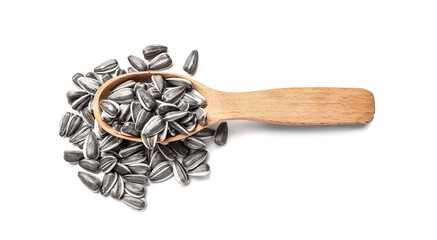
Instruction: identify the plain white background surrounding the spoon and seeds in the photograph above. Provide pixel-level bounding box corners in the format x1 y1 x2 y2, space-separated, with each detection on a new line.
0 0 437 240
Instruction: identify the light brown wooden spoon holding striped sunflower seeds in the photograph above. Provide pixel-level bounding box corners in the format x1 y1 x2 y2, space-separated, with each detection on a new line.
93 72 375 142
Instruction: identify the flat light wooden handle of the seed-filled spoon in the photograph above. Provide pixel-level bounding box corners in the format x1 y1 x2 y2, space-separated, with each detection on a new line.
209 88 375 125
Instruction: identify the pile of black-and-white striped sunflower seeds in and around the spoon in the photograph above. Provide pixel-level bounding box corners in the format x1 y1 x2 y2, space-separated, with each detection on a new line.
59 45 228 210
